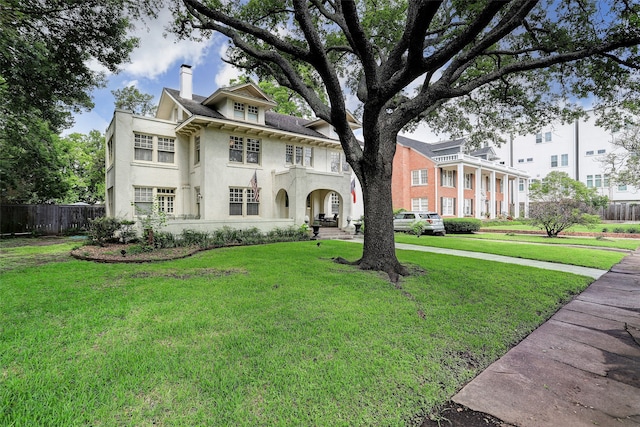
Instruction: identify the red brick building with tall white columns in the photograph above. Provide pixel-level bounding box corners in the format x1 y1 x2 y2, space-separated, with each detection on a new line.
392 136 529 218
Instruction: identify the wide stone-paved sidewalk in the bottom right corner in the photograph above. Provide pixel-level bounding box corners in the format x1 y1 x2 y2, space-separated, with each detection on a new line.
453 250 640 427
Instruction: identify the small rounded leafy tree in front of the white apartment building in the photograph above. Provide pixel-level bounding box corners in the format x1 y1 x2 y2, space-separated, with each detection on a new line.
529 171 609 237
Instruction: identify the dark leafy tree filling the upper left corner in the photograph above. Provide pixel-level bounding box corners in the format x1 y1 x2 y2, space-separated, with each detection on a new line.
0 0 155 203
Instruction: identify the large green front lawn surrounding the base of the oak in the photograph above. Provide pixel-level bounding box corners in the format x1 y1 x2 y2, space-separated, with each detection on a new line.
0 239 591 426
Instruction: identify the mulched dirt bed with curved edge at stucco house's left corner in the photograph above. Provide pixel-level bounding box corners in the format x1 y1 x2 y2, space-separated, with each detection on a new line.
71 243 200 263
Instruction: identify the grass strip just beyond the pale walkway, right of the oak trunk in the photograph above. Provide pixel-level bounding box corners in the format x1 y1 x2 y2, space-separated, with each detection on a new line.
395 233 626 270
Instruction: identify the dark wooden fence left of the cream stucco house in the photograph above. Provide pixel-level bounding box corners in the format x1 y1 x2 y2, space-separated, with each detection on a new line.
0 205 105 235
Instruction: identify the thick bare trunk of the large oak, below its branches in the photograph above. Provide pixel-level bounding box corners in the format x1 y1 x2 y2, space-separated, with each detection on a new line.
360 157 407 282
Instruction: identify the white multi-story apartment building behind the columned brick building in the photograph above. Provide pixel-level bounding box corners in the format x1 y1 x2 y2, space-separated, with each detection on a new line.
494 112 640 203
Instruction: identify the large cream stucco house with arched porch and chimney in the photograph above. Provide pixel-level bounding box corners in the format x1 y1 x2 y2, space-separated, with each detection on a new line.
106 65 360 232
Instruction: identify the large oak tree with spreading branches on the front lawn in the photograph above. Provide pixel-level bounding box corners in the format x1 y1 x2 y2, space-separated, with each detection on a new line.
173 0 640 278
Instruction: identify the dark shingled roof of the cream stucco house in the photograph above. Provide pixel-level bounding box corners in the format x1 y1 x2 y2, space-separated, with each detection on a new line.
164 88 331 139
